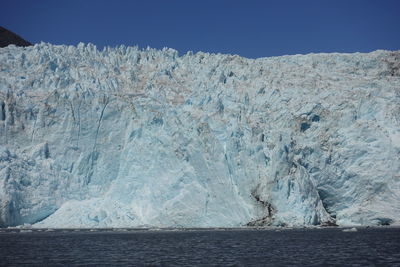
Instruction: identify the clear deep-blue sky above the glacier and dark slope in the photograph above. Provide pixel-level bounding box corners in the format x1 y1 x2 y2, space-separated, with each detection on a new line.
0 0 400 58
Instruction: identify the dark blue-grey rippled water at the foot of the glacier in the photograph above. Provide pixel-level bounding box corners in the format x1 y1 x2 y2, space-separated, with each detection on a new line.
0 228 400 266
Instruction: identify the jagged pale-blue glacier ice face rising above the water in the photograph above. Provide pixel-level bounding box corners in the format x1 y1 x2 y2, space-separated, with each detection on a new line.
0 44 400 227
